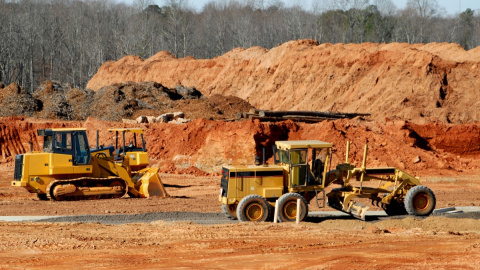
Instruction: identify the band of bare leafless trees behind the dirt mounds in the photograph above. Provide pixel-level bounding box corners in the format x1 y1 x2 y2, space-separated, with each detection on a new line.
0 0 480 92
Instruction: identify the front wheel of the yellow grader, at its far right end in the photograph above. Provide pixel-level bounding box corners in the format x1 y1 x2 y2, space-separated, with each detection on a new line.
405 186 437 216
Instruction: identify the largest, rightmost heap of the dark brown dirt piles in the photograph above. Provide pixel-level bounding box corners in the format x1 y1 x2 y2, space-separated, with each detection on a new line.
90 82 253 121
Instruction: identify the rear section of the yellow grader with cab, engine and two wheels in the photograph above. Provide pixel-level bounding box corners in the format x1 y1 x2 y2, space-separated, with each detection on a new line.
219 140 332 222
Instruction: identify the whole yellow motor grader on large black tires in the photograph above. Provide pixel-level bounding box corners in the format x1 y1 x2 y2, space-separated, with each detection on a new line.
219 140 436 222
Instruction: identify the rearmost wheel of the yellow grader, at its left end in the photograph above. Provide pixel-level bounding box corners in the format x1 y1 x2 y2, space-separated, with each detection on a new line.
237 194 270 222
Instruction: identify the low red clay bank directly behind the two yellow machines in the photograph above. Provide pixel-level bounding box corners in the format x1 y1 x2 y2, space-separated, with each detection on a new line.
0 118 480 175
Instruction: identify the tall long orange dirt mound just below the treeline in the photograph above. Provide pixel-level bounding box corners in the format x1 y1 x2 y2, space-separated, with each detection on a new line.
87 40 480 123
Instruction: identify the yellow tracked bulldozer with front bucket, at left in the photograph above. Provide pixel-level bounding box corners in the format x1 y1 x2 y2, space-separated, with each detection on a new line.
11 128 168 201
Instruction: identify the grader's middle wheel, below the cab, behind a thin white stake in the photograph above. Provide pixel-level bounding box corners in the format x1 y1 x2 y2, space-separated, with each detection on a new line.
278 193 308 222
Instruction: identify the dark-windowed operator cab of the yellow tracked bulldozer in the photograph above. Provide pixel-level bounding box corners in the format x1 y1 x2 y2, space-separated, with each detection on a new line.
38 128 91 166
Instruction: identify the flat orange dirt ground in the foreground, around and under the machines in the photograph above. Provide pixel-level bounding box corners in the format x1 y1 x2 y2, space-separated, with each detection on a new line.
0 164 480 269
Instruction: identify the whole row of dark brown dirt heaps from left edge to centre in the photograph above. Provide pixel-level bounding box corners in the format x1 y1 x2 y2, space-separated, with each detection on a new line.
0 81 253 121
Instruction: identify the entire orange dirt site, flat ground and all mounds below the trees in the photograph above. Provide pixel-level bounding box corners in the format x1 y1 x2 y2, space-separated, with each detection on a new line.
0 40 480 270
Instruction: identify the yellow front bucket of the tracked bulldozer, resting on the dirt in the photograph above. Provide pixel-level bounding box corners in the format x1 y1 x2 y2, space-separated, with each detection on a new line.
134 168 168 198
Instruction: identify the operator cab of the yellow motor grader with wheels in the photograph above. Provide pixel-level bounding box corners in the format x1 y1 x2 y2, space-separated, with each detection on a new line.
274 140 332 188
